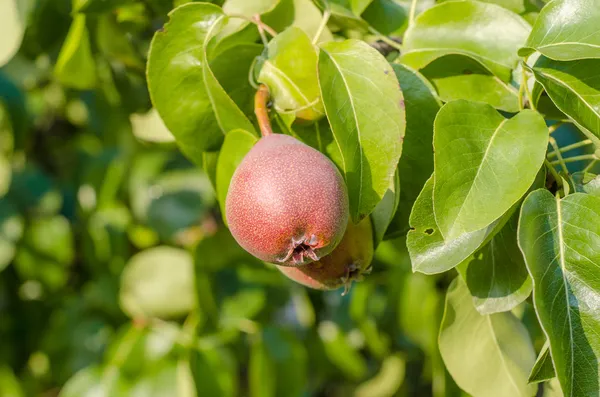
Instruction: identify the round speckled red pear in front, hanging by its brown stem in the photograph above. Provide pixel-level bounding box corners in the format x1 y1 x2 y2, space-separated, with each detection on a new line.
226 134 348 266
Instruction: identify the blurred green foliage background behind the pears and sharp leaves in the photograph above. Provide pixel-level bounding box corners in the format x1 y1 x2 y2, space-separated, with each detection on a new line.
0 0 556 397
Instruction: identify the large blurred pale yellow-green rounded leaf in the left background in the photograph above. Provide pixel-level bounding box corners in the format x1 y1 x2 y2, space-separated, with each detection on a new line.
119 246 196 318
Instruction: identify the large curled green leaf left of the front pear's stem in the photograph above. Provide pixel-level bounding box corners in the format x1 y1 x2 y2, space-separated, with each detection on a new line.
148 3 254 165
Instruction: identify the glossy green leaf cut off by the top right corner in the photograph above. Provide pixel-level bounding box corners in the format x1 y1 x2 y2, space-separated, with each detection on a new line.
519 0 600 61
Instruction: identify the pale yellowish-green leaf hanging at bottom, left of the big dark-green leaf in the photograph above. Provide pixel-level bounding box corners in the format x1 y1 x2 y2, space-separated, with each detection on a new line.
439 277 536 397
